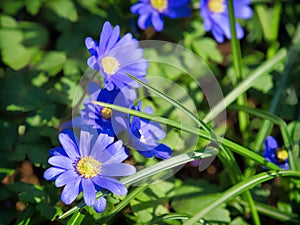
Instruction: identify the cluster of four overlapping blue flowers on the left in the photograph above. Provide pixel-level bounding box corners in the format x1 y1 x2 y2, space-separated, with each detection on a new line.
44 22 172 212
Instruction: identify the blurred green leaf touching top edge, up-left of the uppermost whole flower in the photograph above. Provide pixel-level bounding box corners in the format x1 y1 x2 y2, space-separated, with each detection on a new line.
46 0 78 22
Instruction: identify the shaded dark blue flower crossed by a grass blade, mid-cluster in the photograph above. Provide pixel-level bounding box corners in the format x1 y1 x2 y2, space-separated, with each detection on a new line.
81 82 136 136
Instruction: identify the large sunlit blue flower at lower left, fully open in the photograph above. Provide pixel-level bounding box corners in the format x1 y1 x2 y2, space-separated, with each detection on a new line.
44 130 136 212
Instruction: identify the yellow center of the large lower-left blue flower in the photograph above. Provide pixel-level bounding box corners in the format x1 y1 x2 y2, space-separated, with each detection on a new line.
76 156 102 178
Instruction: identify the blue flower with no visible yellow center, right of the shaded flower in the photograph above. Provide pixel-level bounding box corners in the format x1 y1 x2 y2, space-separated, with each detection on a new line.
116 102 172 159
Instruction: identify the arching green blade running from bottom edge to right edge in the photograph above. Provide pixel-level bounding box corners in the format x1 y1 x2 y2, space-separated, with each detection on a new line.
184 170 300 225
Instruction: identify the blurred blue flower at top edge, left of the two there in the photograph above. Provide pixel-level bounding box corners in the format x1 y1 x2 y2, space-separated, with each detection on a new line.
130 0 191 31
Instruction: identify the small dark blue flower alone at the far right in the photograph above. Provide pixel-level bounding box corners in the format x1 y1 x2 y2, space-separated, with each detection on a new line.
263 136 290 170
